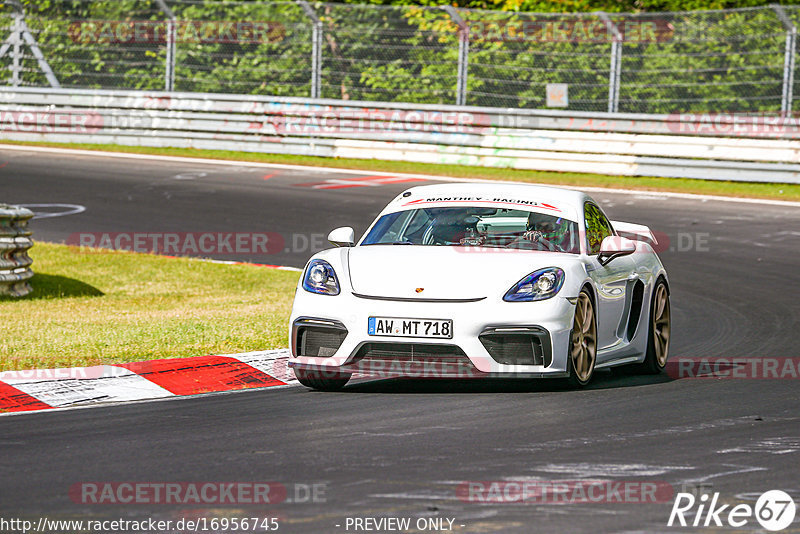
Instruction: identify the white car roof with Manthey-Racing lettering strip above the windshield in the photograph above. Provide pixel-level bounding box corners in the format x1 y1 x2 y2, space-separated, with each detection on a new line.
383 182 591 220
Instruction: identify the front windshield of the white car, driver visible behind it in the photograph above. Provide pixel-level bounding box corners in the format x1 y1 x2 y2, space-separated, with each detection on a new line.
361 206 580 254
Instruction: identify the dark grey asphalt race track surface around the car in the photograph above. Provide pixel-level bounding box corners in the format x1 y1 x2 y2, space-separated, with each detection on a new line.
0 144 800 533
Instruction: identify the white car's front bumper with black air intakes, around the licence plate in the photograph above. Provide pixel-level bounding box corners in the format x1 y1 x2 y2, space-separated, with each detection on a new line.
289 288 575 378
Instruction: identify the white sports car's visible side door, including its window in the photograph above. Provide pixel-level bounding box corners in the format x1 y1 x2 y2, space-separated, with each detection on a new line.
584 202 636 354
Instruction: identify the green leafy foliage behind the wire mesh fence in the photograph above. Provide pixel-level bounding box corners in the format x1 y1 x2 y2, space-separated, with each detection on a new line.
0 0 800 113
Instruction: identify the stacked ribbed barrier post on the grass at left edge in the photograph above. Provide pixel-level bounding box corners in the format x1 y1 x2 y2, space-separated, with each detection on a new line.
0 204 33 297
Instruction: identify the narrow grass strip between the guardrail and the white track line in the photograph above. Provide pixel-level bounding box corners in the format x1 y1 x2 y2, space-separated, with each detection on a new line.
0 141 800 201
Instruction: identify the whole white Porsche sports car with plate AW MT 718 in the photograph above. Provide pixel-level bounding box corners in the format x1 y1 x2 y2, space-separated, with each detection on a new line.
289 183 670 390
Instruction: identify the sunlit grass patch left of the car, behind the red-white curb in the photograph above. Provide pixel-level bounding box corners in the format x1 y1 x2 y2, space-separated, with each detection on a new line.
0 242 298 371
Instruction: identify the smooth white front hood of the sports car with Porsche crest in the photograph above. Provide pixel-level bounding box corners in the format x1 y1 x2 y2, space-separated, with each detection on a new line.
348 245 577 300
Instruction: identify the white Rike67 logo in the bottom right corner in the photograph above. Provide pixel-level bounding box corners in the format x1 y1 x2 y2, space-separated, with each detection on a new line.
667 490 796 532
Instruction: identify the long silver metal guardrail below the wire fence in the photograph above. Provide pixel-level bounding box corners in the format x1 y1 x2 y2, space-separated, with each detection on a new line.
0 88 800 183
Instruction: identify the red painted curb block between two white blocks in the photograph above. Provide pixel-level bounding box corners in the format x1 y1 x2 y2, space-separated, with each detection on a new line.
118 356 285 395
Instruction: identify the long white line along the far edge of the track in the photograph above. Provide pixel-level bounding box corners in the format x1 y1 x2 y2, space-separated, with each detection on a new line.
0 143 800 208
